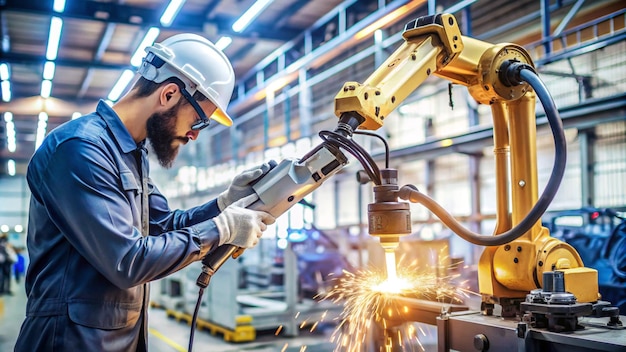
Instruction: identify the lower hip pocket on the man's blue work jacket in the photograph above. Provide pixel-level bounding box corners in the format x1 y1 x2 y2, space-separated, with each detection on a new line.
67 301 141 330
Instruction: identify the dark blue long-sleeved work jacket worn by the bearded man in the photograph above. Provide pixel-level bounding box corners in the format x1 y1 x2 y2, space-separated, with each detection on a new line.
15 101 219 352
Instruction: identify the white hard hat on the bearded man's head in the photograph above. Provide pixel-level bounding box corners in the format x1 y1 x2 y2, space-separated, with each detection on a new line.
138 33 235 126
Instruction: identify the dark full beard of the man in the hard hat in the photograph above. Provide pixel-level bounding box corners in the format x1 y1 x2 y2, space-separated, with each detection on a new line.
146 102 189 169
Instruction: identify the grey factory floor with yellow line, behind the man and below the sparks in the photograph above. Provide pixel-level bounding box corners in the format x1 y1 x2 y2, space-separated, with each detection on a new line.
0 282 436 352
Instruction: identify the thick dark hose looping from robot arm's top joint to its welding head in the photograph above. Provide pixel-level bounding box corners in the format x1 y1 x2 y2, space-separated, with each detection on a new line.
399 64 567 246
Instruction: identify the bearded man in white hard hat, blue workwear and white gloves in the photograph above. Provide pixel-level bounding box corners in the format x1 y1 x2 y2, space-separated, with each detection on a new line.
15 34 275 352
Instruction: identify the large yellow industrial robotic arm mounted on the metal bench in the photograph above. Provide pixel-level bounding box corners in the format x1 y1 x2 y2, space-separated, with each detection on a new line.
335 14 599 315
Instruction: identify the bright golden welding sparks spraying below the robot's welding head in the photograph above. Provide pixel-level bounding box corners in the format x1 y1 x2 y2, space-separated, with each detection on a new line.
316 248 467 352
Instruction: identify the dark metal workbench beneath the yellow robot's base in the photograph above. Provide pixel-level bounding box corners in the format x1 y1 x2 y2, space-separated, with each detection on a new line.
437 311 626 352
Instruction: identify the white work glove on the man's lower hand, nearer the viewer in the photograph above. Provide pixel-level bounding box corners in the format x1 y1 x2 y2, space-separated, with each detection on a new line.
213 194 276 248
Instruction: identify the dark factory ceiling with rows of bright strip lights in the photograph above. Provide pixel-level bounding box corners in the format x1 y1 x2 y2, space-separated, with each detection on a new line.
0 0 619 176
